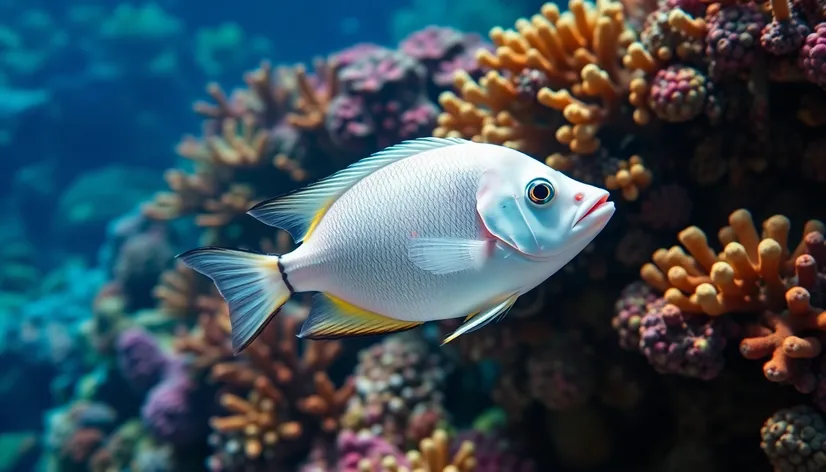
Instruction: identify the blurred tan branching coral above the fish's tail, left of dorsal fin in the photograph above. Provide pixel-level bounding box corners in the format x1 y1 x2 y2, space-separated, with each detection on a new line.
143 62 346 244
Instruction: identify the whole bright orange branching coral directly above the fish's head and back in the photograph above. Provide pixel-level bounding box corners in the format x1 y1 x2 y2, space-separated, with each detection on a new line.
434 0 634 155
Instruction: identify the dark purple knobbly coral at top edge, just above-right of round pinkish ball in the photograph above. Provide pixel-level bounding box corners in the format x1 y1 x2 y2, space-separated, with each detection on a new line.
706 3 765 78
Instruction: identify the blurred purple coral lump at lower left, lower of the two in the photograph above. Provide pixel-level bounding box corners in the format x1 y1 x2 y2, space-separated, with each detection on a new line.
141 375 203 446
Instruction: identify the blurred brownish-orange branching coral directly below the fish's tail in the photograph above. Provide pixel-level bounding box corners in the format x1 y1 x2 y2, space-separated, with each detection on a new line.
198 310 354 464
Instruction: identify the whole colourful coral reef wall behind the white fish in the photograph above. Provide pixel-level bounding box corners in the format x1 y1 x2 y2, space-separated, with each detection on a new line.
9 0 826 472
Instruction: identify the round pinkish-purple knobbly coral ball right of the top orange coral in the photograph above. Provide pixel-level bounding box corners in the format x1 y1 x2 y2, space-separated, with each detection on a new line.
648 65 708 123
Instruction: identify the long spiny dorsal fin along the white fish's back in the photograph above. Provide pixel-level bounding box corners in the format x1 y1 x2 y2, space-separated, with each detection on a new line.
247 138 470 243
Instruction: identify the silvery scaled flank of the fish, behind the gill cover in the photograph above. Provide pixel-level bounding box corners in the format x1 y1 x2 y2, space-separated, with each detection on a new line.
288 142 490 320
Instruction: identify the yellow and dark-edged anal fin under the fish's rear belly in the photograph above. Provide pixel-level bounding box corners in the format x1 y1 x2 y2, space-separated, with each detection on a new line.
298 293 422 340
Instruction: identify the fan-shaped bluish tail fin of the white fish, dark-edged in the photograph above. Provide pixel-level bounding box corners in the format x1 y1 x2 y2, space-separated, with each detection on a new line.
178 247 293 354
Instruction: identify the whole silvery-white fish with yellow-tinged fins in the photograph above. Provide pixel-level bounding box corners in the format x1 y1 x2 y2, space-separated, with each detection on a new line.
180 138 614 352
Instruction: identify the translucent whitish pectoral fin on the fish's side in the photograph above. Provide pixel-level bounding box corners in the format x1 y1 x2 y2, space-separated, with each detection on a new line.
407 238 495 275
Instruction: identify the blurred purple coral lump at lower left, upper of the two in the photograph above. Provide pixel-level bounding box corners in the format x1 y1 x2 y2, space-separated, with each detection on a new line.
116 328 168 395
